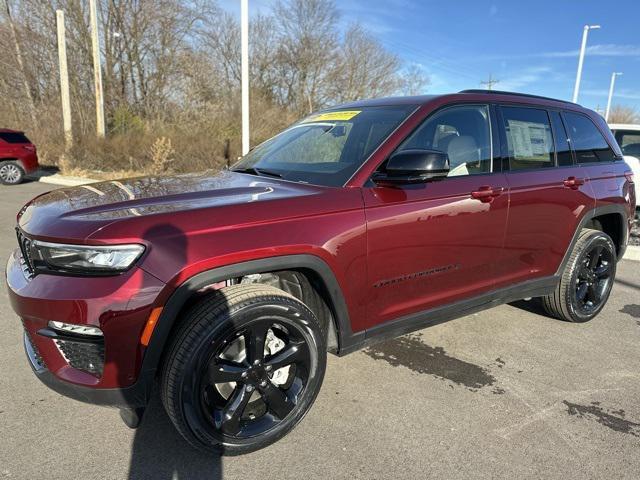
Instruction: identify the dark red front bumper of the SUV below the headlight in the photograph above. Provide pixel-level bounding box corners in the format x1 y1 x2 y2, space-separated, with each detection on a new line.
6 250 165 406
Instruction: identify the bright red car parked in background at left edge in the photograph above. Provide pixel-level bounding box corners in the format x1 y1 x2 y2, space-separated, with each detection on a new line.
0 128 38 185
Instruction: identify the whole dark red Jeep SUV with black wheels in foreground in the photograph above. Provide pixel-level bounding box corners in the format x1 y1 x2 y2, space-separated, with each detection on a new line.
7 91 635 454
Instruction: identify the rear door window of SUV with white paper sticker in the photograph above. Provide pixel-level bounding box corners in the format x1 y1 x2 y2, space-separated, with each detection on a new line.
501 107 555 170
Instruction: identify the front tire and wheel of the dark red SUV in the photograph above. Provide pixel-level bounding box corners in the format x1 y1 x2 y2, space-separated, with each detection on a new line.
161 284 326 455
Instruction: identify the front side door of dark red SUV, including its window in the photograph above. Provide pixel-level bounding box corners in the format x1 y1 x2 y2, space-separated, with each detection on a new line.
363 105 509 328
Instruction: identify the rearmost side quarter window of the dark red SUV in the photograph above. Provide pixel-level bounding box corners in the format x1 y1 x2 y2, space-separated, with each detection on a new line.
563 112 615 163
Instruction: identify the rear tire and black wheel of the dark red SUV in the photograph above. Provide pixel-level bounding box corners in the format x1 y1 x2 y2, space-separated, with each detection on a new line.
542 228 617 322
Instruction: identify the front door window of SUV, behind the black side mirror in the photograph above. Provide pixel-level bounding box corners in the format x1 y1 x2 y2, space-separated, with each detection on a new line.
398 105 492 177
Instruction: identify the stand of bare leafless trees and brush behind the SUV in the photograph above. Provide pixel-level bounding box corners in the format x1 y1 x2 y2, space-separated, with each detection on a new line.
0 0 427 171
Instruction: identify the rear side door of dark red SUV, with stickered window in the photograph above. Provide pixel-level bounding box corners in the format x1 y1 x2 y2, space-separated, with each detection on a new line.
499 105 594 285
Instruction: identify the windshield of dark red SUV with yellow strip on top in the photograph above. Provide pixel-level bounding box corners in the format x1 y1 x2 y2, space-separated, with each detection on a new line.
232 105 417 187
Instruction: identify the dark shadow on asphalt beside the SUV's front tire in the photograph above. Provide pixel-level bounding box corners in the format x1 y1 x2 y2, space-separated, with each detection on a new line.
128 392 222 480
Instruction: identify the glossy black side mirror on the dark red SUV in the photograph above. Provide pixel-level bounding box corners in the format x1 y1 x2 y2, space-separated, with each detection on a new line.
372 149 449 185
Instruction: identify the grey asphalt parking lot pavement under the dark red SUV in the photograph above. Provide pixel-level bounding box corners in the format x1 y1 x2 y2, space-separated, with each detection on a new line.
0 182 640 480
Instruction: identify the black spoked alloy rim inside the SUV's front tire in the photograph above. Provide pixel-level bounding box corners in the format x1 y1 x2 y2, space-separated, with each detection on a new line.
200 317 312 438
